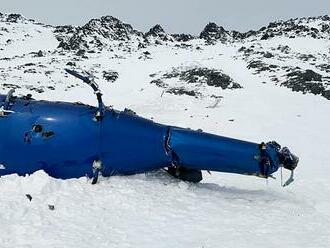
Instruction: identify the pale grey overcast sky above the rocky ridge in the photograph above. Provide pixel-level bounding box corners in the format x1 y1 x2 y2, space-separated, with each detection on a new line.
0 0 330 34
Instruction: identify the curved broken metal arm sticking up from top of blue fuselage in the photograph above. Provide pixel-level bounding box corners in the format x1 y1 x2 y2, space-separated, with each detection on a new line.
65 69 104 121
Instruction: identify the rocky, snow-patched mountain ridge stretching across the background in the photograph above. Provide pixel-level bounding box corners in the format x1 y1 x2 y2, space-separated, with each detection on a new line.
0 14 330 99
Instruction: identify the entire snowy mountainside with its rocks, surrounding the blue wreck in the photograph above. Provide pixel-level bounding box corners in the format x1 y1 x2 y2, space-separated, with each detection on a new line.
0 15 330 248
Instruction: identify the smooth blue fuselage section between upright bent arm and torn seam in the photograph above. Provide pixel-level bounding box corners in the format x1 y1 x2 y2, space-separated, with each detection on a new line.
101 111 170 174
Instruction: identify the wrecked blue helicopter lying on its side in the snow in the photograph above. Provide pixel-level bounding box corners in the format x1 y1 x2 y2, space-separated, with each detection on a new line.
0 70 299 186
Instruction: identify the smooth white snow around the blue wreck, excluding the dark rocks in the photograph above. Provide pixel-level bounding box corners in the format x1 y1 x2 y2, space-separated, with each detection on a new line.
0 14 330 248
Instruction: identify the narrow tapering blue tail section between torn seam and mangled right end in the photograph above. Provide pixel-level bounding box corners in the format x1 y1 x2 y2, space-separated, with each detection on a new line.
170 128 279 175
